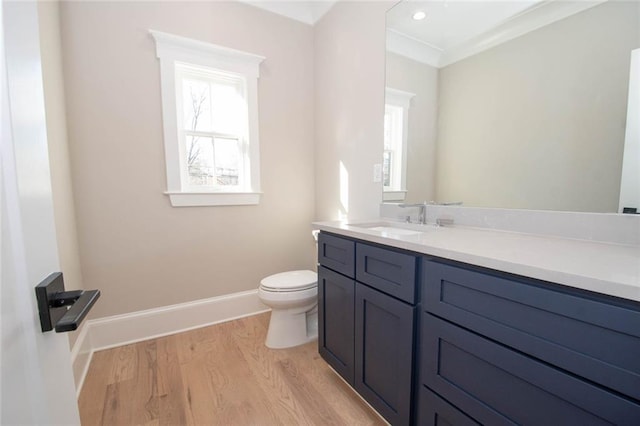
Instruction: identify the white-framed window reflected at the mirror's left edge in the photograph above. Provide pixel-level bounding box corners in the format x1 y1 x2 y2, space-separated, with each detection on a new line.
382 87 415 201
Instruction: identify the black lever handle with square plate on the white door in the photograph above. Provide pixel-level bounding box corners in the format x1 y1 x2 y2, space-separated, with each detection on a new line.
36 272 100 333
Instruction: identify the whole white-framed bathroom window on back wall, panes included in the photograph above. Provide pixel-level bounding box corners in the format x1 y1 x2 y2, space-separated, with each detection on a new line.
150 31 264 206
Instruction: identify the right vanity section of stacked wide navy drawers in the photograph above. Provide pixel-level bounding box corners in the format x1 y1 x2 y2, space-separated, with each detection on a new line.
418 259 640 425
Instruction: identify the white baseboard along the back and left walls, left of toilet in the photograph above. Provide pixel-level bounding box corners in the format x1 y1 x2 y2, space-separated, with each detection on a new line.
71 290 269 396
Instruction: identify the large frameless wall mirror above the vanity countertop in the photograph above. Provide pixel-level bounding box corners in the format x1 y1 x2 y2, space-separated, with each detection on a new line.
383 0 640 213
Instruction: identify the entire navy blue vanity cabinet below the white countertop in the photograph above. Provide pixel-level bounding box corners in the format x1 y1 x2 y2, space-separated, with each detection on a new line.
318 232 640 426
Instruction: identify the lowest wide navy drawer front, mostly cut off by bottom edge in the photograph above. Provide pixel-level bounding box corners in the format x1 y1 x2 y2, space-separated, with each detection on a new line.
416 386 480 426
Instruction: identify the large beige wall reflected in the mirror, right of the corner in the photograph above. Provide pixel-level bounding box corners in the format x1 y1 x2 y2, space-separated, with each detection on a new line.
437 2 639 212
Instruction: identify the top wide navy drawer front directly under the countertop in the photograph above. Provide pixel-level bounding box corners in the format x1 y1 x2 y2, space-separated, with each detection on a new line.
423 261 640 400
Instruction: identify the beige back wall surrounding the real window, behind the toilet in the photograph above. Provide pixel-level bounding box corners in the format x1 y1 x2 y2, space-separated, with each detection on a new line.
61 1 315 317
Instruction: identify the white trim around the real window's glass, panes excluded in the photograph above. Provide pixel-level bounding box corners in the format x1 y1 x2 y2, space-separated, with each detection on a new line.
149 30 265 207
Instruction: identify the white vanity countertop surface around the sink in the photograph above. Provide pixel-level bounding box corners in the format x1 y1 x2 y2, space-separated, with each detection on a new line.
314 220 640 301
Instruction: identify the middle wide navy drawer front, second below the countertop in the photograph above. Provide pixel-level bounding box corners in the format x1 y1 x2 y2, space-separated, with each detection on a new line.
421 314 640 426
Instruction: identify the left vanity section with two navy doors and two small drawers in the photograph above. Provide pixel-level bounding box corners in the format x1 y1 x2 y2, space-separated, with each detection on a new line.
318 232 421 426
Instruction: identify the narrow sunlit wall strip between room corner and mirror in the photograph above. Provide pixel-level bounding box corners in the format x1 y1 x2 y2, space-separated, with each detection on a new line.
314 1 392 220
